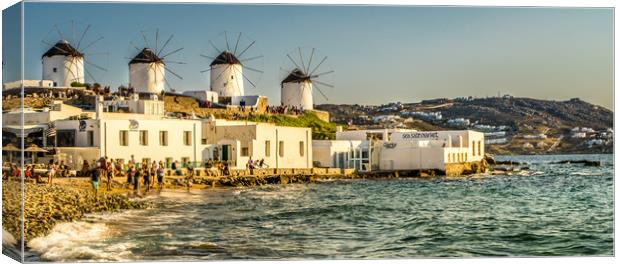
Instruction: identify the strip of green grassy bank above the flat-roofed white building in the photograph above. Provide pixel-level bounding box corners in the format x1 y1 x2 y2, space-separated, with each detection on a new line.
248 113 336 139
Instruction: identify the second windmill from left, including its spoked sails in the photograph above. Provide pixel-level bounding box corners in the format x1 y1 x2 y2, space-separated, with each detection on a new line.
129 29 186 94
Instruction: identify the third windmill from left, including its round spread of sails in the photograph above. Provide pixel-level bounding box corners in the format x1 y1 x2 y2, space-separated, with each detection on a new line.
200 32 263 97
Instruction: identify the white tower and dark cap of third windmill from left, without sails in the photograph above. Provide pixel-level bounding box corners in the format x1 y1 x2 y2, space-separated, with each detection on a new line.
210 51 245 97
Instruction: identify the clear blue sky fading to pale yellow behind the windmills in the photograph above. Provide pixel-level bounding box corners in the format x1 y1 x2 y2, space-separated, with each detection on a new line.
3 3 613 109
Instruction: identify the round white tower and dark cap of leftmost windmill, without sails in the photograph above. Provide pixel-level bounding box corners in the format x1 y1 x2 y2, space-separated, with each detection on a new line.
41 40 84 87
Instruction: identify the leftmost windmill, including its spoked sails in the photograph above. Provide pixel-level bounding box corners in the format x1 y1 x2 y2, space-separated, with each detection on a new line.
41 20 109 87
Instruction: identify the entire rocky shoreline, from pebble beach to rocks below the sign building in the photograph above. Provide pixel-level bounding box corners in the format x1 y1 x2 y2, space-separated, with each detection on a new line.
2 162 488 242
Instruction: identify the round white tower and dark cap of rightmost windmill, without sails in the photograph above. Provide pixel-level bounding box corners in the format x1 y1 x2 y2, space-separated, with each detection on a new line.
280 69 314 110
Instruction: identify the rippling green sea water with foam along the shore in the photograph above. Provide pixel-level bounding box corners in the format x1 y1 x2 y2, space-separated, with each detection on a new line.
21 155 614 261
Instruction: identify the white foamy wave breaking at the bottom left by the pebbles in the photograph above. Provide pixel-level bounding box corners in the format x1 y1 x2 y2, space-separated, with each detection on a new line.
28 221 135 261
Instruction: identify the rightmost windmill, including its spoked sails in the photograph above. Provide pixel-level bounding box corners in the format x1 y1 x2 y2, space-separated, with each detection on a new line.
280 48 334 110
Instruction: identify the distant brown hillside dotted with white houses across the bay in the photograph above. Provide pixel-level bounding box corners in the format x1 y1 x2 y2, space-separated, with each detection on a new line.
316 96 613 154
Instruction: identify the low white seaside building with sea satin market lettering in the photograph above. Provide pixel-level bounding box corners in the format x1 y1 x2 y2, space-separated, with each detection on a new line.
313 129 484 171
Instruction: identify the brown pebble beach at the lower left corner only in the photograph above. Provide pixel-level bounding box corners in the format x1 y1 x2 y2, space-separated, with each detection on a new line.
2 181 148 242
